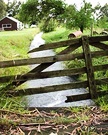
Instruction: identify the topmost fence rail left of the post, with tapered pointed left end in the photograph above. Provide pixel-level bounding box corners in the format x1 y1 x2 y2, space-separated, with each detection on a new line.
28 38 81 53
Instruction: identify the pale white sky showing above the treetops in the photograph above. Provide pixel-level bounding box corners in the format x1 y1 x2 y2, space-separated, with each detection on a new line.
4 0 108 8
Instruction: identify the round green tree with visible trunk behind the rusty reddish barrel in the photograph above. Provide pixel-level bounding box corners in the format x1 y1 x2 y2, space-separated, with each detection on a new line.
63 0 93 32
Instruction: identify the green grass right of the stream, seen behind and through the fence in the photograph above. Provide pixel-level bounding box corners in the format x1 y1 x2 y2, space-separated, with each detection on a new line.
43 28 108 110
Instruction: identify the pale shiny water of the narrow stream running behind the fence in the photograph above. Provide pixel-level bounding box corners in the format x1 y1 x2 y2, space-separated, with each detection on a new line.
26 33 94 107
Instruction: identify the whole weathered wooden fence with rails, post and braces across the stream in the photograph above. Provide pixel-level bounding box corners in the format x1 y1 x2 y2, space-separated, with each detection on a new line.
0 36 108 102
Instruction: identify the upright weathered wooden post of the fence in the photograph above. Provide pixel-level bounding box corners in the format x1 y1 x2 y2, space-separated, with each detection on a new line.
82 36 97 99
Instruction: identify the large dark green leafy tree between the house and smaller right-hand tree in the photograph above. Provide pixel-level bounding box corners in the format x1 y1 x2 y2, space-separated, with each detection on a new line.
20 0 65 30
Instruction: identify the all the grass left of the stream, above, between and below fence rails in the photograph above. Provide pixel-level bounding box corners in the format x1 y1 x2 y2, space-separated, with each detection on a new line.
0 28 39 110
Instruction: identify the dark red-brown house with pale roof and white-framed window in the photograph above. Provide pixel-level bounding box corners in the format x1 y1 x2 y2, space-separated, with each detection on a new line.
0 16 24 31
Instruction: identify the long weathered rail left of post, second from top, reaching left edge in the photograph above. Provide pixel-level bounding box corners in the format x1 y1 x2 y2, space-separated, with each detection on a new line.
0 53 83 68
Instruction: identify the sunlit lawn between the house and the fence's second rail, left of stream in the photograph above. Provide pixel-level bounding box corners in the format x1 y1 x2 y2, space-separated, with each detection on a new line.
0 29 38 60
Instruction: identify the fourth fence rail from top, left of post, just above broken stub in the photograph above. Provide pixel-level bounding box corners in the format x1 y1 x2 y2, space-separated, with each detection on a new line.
6 81 88 96
